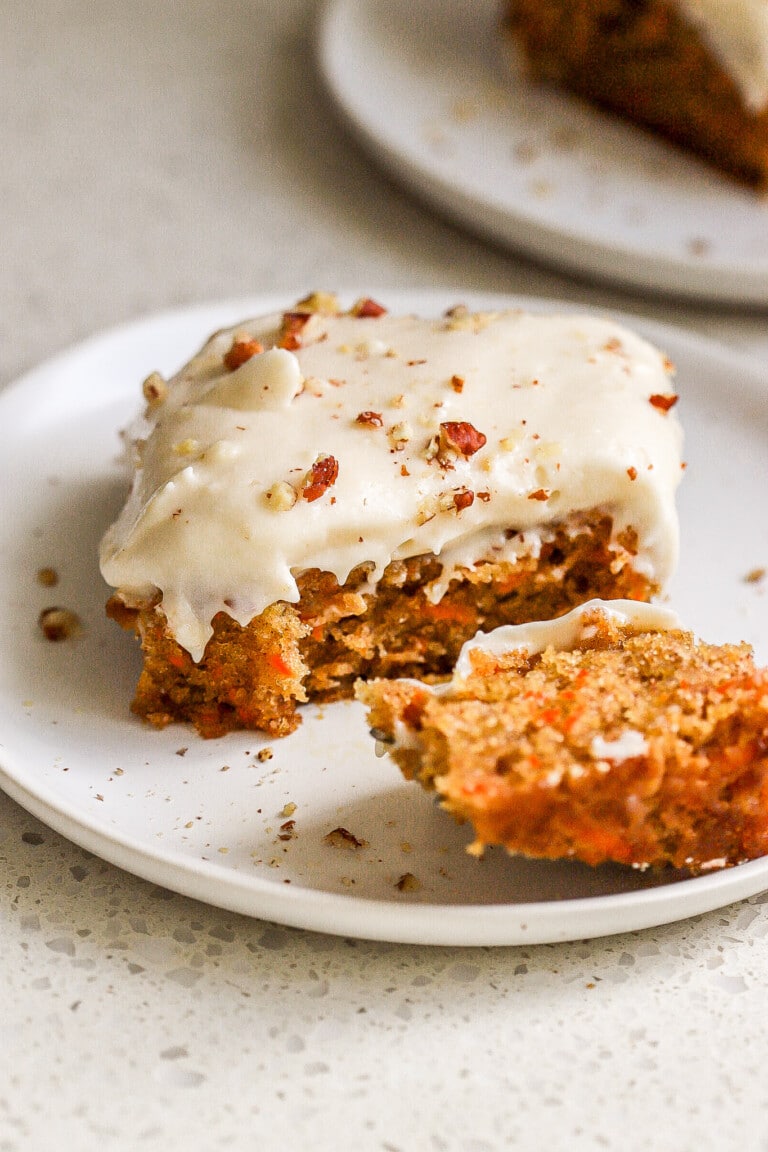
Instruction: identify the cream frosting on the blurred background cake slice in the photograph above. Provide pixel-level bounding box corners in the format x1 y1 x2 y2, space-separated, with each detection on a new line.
677 0 768 112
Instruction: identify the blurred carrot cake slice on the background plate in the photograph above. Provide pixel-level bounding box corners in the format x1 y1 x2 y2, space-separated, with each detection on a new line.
507 0 768 188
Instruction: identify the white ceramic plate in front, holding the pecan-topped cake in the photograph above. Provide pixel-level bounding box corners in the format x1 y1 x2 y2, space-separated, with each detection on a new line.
0 293 768 945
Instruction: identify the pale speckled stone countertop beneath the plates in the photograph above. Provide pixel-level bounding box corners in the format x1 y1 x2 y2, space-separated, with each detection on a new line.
0 0 768 1152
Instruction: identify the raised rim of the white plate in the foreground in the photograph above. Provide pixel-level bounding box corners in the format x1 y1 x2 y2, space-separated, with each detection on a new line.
0 287 768 947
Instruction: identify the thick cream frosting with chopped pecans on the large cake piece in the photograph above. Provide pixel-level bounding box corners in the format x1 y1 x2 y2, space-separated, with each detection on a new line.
101 311 680 659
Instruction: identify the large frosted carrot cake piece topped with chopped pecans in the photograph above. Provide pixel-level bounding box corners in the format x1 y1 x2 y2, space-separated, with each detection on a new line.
101 294 680 736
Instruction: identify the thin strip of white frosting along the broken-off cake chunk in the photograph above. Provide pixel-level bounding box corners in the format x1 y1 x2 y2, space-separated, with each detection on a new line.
454 600 680 680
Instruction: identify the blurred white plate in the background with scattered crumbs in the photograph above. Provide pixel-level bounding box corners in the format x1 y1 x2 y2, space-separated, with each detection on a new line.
317 0 768 304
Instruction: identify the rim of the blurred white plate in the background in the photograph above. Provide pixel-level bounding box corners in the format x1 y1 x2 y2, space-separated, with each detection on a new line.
314 0 768 310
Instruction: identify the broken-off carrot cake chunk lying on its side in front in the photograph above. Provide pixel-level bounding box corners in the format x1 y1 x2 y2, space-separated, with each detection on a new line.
358 601 768 871
